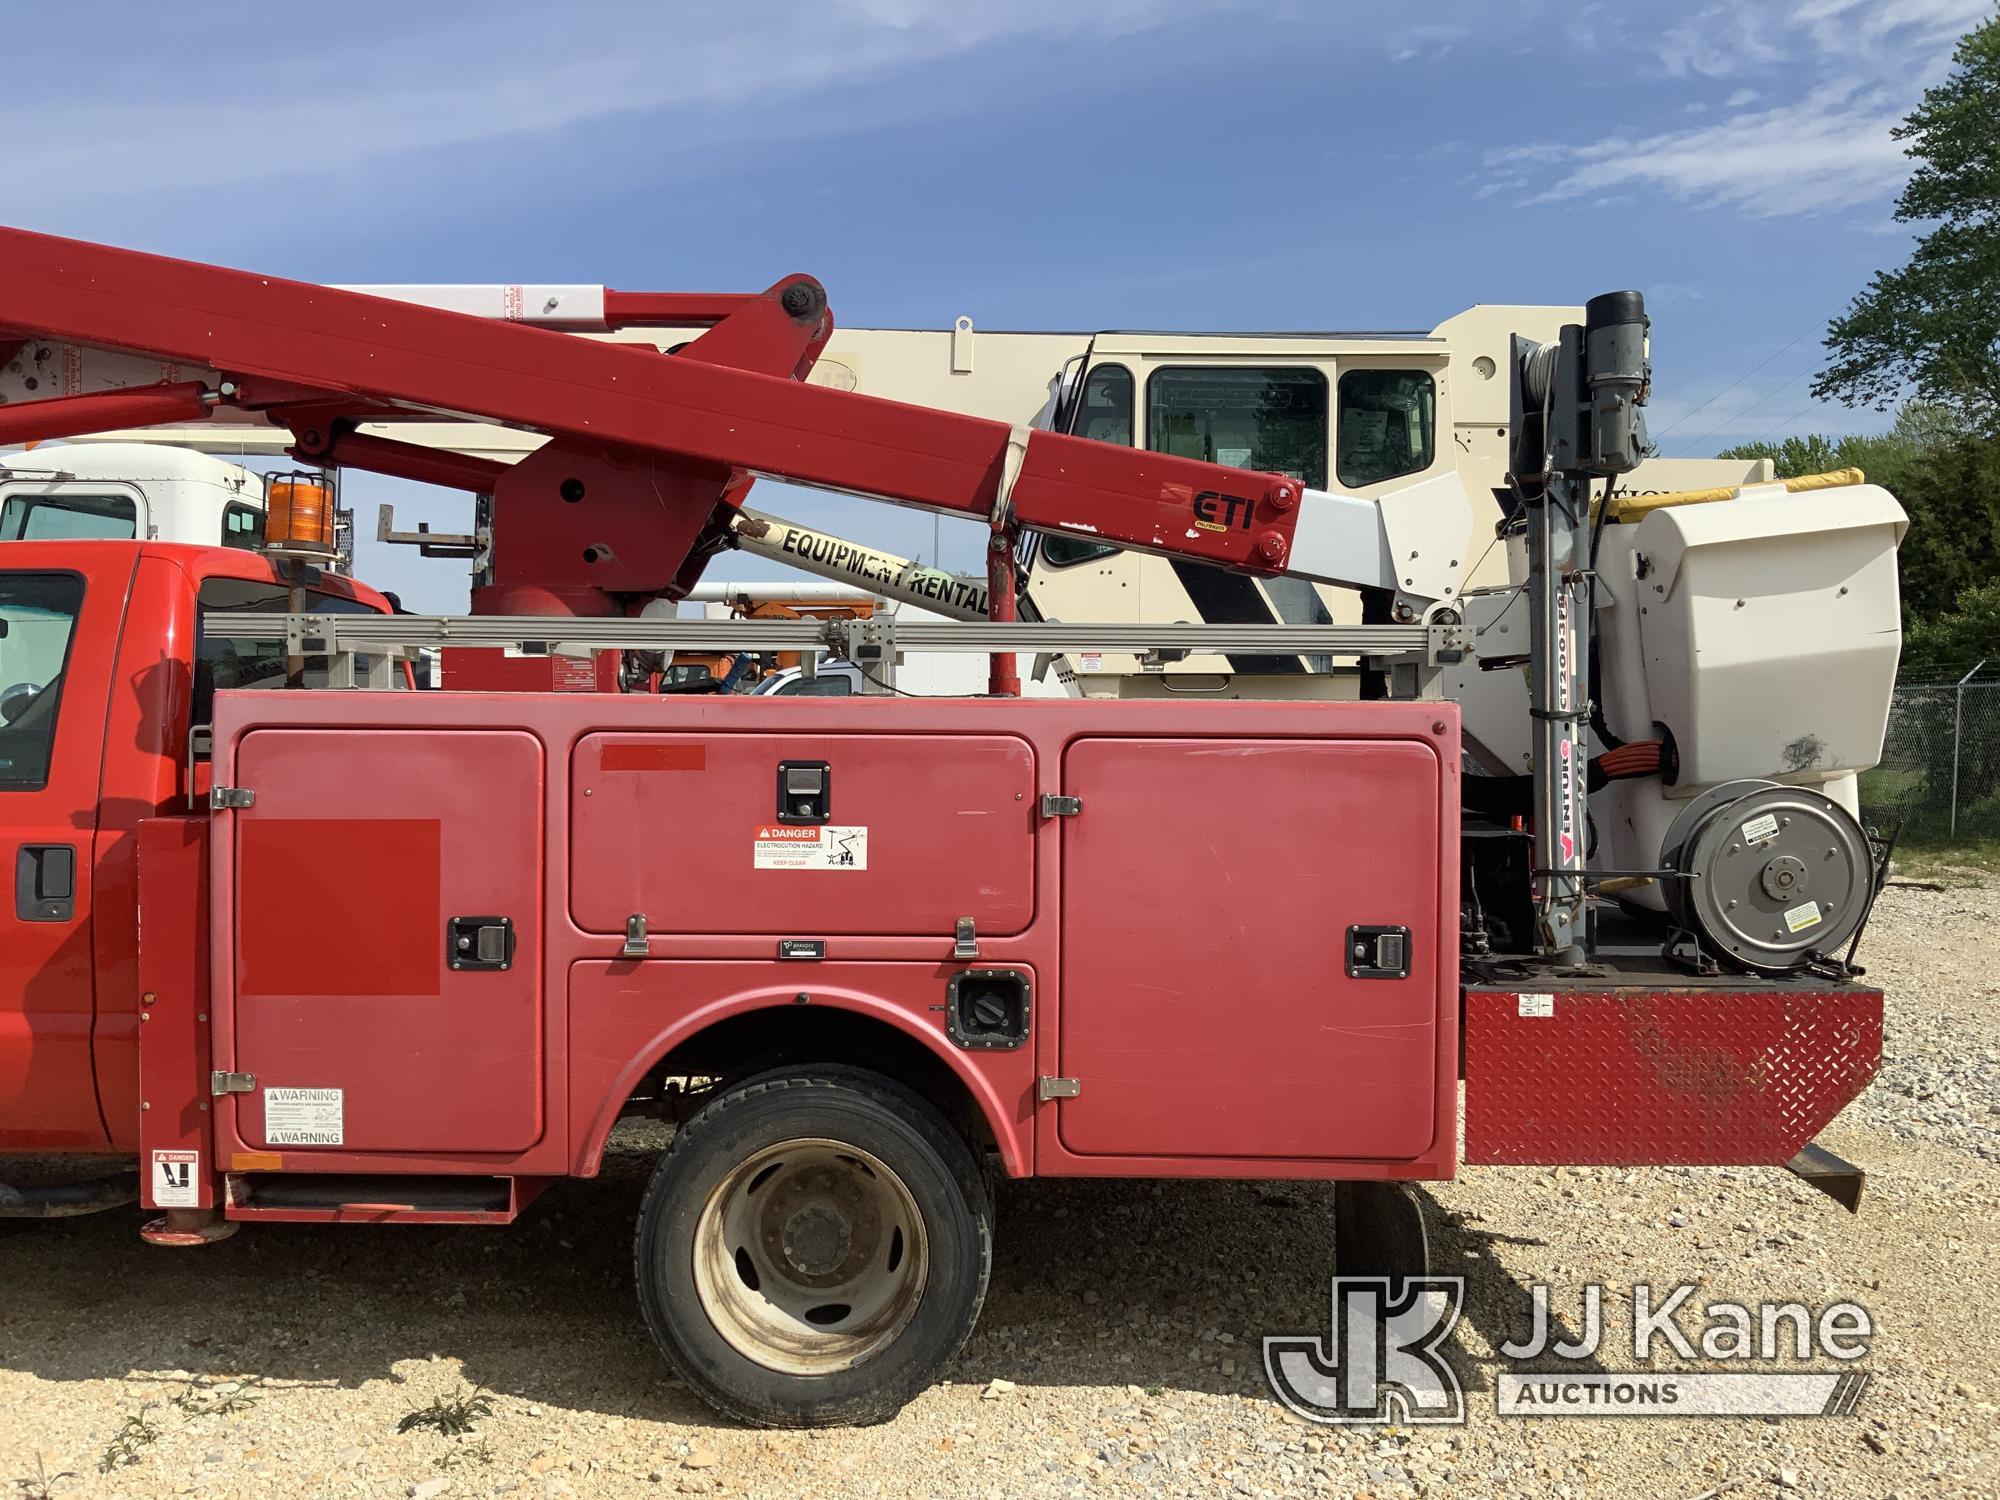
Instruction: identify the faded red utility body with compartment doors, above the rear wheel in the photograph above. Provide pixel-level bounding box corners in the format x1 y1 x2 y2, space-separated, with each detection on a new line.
184 694 1458 1212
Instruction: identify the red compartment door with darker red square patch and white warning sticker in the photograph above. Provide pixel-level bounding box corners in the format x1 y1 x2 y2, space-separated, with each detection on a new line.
218 728 542 1168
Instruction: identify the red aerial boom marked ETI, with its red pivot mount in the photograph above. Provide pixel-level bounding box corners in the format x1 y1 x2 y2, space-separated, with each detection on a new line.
0 228 1300 614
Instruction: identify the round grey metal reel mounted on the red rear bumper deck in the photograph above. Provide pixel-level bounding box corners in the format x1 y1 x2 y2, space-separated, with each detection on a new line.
1660 780 1876 974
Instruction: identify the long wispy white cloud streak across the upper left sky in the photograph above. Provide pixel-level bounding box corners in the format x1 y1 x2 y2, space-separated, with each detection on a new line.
0 0 1228 210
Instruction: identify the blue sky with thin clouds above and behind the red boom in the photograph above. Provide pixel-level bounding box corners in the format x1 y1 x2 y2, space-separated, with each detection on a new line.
0 0 1992 608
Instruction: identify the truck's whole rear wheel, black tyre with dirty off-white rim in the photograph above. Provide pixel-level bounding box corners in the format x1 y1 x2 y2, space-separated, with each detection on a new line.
636 1068 992 1426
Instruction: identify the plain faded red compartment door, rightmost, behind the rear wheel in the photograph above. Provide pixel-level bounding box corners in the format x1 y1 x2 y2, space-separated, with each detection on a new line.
1060 740 1456 1160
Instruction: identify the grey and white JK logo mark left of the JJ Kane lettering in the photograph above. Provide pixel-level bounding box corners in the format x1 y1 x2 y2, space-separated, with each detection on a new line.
1264 1276 1466 1424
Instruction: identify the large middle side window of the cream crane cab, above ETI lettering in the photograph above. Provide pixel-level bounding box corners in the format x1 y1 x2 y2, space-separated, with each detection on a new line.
1146 366 1326 490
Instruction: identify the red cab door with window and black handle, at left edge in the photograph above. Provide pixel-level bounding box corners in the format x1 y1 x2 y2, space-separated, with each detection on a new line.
0 560 123 1152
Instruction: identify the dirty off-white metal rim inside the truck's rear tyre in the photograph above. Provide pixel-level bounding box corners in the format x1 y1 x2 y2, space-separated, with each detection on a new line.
694 1138 930 1376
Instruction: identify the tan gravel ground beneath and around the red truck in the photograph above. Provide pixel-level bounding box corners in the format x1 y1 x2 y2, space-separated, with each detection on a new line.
0 876 2000 1500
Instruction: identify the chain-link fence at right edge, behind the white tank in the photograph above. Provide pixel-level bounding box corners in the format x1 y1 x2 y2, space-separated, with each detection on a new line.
1862 682 2000 844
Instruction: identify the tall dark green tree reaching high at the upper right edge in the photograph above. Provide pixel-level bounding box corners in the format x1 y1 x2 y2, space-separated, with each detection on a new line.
1812 16 2000 434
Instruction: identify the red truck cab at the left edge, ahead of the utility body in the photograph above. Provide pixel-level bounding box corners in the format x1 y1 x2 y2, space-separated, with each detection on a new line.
0 548 394 1156
